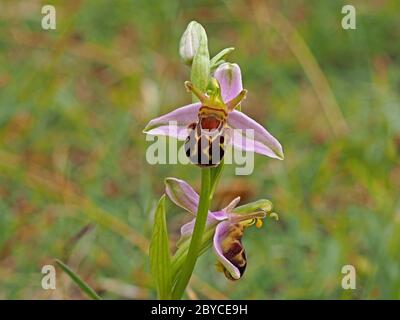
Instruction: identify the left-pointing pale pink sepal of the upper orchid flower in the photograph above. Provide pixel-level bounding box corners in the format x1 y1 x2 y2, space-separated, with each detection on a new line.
143 102 201 139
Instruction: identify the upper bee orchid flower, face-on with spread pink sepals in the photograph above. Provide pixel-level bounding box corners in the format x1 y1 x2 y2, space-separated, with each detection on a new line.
143 62 284 166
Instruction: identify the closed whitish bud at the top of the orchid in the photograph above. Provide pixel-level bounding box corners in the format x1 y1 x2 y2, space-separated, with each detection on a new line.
179 21 207 66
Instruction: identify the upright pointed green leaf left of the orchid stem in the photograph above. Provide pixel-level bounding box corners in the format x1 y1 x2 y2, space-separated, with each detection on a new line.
150 195 172 299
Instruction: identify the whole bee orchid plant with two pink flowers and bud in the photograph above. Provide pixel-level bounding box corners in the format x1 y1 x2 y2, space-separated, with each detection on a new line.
144 21 283 299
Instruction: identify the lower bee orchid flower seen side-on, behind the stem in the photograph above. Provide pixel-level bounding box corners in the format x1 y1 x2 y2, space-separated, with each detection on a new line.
165 178 272 280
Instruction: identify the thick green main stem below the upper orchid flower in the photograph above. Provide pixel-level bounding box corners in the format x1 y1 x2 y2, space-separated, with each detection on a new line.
172 168 211 299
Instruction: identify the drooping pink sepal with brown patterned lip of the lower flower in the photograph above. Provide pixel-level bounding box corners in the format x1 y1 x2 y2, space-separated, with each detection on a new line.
213 221 247 280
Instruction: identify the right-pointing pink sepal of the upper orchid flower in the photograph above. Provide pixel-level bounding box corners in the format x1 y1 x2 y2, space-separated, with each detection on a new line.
228 110 284 160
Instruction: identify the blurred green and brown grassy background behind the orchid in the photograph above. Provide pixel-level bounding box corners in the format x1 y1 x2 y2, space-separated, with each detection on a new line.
0 0 400 299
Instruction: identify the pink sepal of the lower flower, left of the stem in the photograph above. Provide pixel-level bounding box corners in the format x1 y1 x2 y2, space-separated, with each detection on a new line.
165 178 199 215
